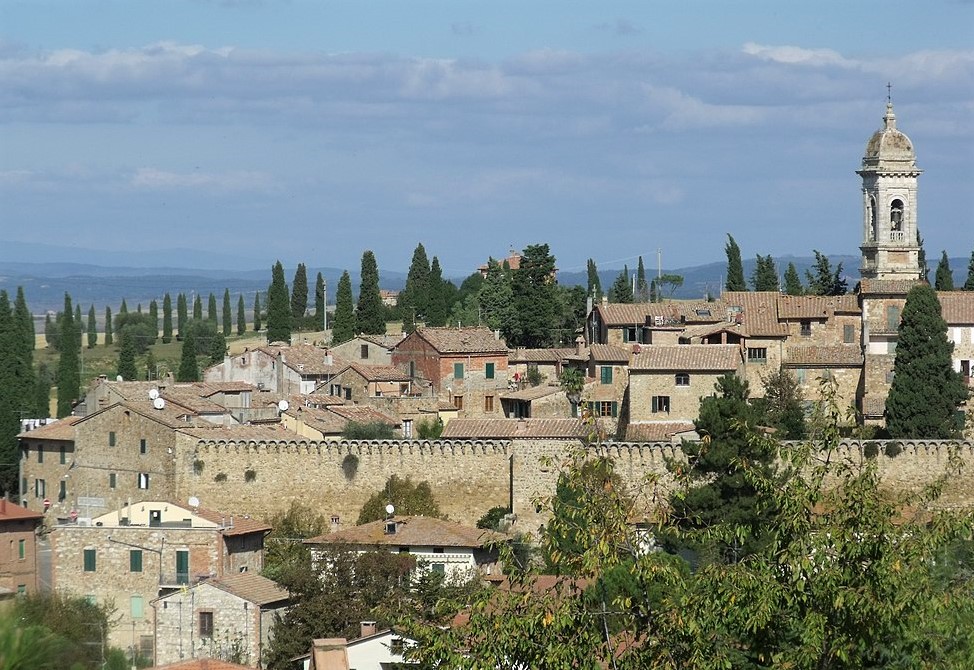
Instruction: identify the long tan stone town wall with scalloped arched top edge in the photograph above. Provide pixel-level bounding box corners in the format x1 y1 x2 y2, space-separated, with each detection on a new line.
177 437 974 532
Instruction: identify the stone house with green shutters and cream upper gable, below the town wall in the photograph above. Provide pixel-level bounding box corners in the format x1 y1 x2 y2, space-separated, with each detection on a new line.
51 500 271 659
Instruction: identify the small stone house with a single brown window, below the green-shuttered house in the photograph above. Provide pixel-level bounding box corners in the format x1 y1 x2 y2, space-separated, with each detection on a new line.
152 572 290 667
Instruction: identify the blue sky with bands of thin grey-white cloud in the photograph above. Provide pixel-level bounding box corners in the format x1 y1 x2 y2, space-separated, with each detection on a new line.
0 0 974 276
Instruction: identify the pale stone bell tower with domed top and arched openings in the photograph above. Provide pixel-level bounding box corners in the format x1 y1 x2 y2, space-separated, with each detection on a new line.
856 101 922 280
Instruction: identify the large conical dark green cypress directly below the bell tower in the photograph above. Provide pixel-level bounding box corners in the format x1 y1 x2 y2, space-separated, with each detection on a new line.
886 284 968 439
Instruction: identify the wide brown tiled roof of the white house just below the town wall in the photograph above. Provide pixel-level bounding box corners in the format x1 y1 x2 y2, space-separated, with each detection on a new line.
305 516 507 548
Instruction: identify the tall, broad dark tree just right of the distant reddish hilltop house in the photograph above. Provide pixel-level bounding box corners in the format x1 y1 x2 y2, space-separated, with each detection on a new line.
507 244 559 349
